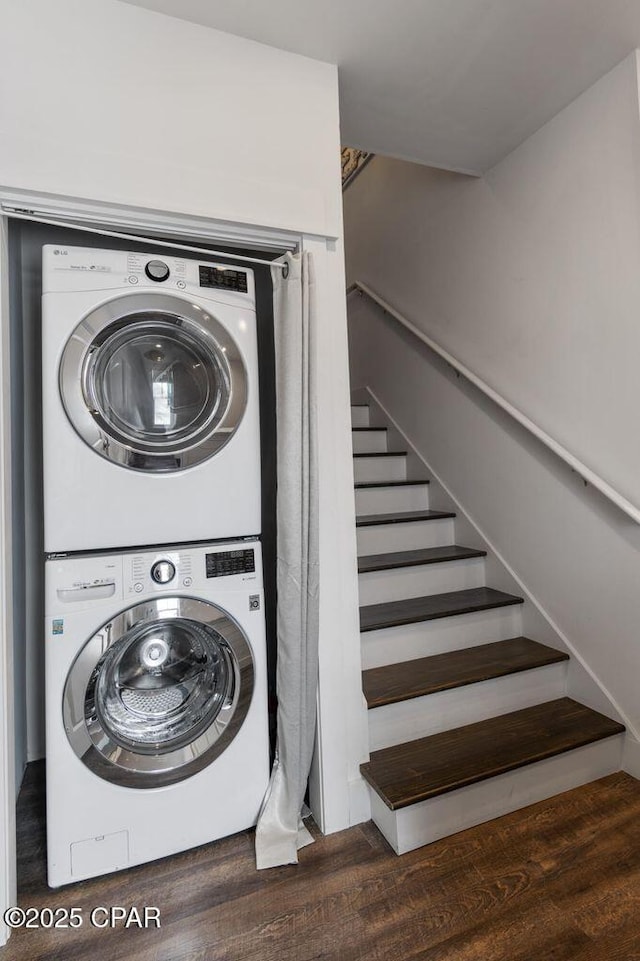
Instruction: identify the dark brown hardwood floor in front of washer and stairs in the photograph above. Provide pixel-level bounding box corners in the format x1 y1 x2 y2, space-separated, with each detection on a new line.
0 765 640 961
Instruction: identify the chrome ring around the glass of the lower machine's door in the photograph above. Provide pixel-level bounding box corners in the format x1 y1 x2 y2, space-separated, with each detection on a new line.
62 596 255 788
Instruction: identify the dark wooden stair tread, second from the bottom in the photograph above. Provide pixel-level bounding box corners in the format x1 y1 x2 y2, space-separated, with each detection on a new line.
362 637 569 709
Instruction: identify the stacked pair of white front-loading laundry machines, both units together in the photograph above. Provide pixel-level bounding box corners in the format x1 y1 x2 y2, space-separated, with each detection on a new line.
42 246 269 887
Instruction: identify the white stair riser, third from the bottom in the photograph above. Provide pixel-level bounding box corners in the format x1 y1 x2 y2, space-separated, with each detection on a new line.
360 604 522 670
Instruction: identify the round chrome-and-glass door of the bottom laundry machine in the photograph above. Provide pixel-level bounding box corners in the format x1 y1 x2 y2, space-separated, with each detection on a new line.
63 597 254 788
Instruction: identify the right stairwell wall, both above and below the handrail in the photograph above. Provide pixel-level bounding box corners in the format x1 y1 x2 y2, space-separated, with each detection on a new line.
345 57 640 733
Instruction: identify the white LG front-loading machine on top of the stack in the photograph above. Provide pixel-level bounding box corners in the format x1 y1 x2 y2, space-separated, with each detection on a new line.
42 245 261 553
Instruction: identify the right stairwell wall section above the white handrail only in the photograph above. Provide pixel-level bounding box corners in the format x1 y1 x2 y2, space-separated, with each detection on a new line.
345 53 640 506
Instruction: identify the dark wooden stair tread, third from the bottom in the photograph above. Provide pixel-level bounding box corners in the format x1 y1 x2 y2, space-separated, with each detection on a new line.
360 587 523 631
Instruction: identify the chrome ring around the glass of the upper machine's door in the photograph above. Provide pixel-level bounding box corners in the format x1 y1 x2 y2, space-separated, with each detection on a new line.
58 293 248 473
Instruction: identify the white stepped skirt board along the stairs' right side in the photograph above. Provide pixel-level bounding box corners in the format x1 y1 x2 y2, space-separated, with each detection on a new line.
351 386 640 777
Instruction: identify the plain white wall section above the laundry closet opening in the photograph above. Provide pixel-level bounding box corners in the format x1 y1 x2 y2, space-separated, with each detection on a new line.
0 0 341 236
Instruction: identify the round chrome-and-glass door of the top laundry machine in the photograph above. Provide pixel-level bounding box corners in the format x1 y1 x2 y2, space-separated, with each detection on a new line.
60 293 247 473
